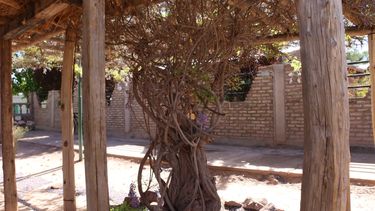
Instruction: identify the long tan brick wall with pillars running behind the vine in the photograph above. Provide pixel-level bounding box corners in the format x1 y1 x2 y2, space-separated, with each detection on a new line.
34 65 374 147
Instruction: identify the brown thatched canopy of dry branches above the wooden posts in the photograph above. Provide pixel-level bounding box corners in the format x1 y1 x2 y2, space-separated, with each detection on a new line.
0 0 375 50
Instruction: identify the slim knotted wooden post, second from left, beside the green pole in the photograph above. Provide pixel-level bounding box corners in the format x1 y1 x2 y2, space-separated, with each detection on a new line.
61 27 76 211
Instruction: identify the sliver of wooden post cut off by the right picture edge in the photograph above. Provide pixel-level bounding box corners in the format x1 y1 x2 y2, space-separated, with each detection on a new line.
368 32 375 143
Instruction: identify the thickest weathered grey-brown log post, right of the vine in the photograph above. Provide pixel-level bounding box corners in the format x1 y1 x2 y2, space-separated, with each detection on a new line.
297 0 350 211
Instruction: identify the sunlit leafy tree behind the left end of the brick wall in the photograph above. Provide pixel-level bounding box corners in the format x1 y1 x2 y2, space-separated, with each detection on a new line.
12 46 129 105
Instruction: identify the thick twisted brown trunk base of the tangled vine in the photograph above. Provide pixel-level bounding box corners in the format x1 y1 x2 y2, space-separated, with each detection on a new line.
167 146 221 211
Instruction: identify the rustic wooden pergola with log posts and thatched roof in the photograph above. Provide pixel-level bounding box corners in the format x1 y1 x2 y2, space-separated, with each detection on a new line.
0 0 375 211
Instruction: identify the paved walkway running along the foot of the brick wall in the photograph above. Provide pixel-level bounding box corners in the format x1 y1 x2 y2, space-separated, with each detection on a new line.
20 130 375 185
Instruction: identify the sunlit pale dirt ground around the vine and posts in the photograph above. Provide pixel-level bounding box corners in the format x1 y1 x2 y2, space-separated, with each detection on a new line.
0 142 375 211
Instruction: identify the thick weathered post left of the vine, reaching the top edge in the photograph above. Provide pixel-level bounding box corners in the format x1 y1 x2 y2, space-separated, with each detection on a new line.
82 0 109 211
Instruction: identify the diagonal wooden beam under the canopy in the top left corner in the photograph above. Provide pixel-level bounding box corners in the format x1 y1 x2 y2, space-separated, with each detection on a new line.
1 0 69 39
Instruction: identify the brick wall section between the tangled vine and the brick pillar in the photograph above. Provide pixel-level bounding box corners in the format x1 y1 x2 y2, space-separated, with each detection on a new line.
215 67 274 145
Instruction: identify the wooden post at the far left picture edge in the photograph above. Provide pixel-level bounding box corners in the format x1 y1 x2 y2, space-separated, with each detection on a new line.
0 39 18 211
